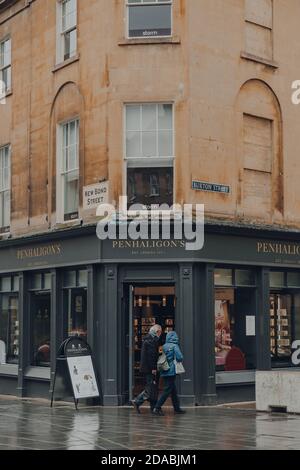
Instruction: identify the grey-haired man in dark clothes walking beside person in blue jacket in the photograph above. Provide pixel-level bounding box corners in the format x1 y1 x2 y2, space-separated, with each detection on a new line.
133 325 162 413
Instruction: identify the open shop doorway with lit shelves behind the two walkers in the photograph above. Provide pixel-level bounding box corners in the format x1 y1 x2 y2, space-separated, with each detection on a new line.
129 286 176 401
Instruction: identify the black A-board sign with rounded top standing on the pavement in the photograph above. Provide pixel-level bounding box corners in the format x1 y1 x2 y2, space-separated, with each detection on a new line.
51 336 99 409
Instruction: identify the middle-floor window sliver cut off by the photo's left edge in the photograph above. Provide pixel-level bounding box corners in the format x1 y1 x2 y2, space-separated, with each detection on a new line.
0 145 10 233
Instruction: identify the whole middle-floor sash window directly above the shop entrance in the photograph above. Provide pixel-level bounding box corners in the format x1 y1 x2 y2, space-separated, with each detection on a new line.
125 104 174 208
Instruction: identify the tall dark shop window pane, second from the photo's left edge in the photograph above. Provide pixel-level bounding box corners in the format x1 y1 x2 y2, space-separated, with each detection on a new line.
31 294 51 367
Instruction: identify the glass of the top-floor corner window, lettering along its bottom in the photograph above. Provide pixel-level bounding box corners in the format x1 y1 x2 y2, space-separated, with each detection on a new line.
129 4 171 37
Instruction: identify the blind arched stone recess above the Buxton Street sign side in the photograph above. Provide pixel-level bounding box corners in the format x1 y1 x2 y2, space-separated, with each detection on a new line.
238 80 284 222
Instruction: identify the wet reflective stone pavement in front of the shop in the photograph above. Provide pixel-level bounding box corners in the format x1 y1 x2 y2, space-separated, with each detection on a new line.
0 397 300 451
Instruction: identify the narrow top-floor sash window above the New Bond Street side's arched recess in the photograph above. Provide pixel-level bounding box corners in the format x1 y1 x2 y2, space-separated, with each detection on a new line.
57 0 77 62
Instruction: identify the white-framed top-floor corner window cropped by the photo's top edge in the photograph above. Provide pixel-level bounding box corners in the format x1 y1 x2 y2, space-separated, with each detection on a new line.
127 0 172 38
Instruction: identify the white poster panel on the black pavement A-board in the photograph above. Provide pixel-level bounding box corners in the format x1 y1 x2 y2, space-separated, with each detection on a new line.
67 356 99 400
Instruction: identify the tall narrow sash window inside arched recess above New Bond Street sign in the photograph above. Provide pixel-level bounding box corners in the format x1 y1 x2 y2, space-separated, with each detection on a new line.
57 119 79 221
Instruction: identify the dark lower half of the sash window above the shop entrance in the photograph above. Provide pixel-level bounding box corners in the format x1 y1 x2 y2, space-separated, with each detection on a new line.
127 168 173 207
